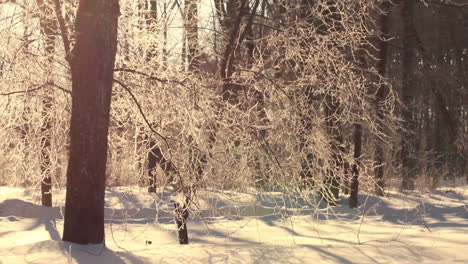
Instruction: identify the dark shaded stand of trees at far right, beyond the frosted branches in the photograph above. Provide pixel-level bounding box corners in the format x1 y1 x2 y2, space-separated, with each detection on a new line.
387 1 467 189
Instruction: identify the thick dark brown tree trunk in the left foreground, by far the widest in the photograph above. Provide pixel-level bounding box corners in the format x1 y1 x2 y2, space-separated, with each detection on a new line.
63 0 120 244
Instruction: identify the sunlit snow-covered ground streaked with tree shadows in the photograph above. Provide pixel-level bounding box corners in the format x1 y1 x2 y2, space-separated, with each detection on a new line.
0 186 468 264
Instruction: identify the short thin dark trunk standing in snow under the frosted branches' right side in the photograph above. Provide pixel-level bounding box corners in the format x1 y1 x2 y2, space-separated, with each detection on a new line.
349 124 362 208
